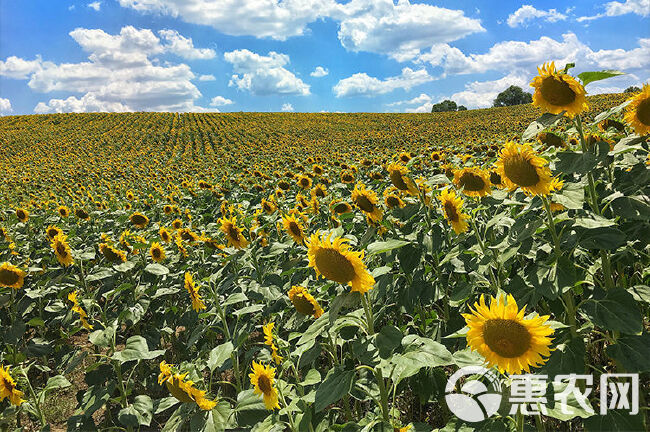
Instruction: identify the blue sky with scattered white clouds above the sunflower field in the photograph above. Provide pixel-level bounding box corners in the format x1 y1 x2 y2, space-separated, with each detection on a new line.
0 0 650 115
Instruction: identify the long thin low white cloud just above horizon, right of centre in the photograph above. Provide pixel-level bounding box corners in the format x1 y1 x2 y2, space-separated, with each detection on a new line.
332 68 434 97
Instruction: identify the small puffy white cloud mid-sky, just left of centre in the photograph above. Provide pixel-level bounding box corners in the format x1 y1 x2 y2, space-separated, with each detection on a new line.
224 49 309 95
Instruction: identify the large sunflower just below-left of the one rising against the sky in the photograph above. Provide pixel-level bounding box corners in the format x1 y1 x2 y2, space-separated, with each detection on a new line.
496 142 551 195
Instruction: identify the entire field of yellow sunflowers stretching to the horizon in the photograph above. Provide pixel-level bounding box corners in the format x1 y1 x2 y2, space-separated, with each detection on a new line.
0 63 650 432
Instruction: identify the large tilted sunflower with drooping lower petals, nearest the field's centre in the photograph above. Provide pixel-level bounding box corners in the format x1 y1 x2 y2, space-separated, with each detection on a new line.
307 231 375 294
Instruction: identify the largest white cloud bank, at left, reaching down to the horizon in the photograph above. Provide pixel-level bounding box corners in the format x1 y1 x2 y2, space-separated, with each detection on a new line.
8 26 211 113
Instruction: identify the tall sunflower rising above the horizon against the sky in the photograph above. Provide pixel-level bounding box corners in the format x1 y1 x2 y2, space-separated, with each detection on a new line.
530 62 589 117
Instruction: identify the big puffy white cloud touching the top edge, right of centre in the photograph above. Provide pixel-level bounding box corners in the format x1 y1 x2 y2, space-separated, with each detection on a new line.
333 0 485 61
